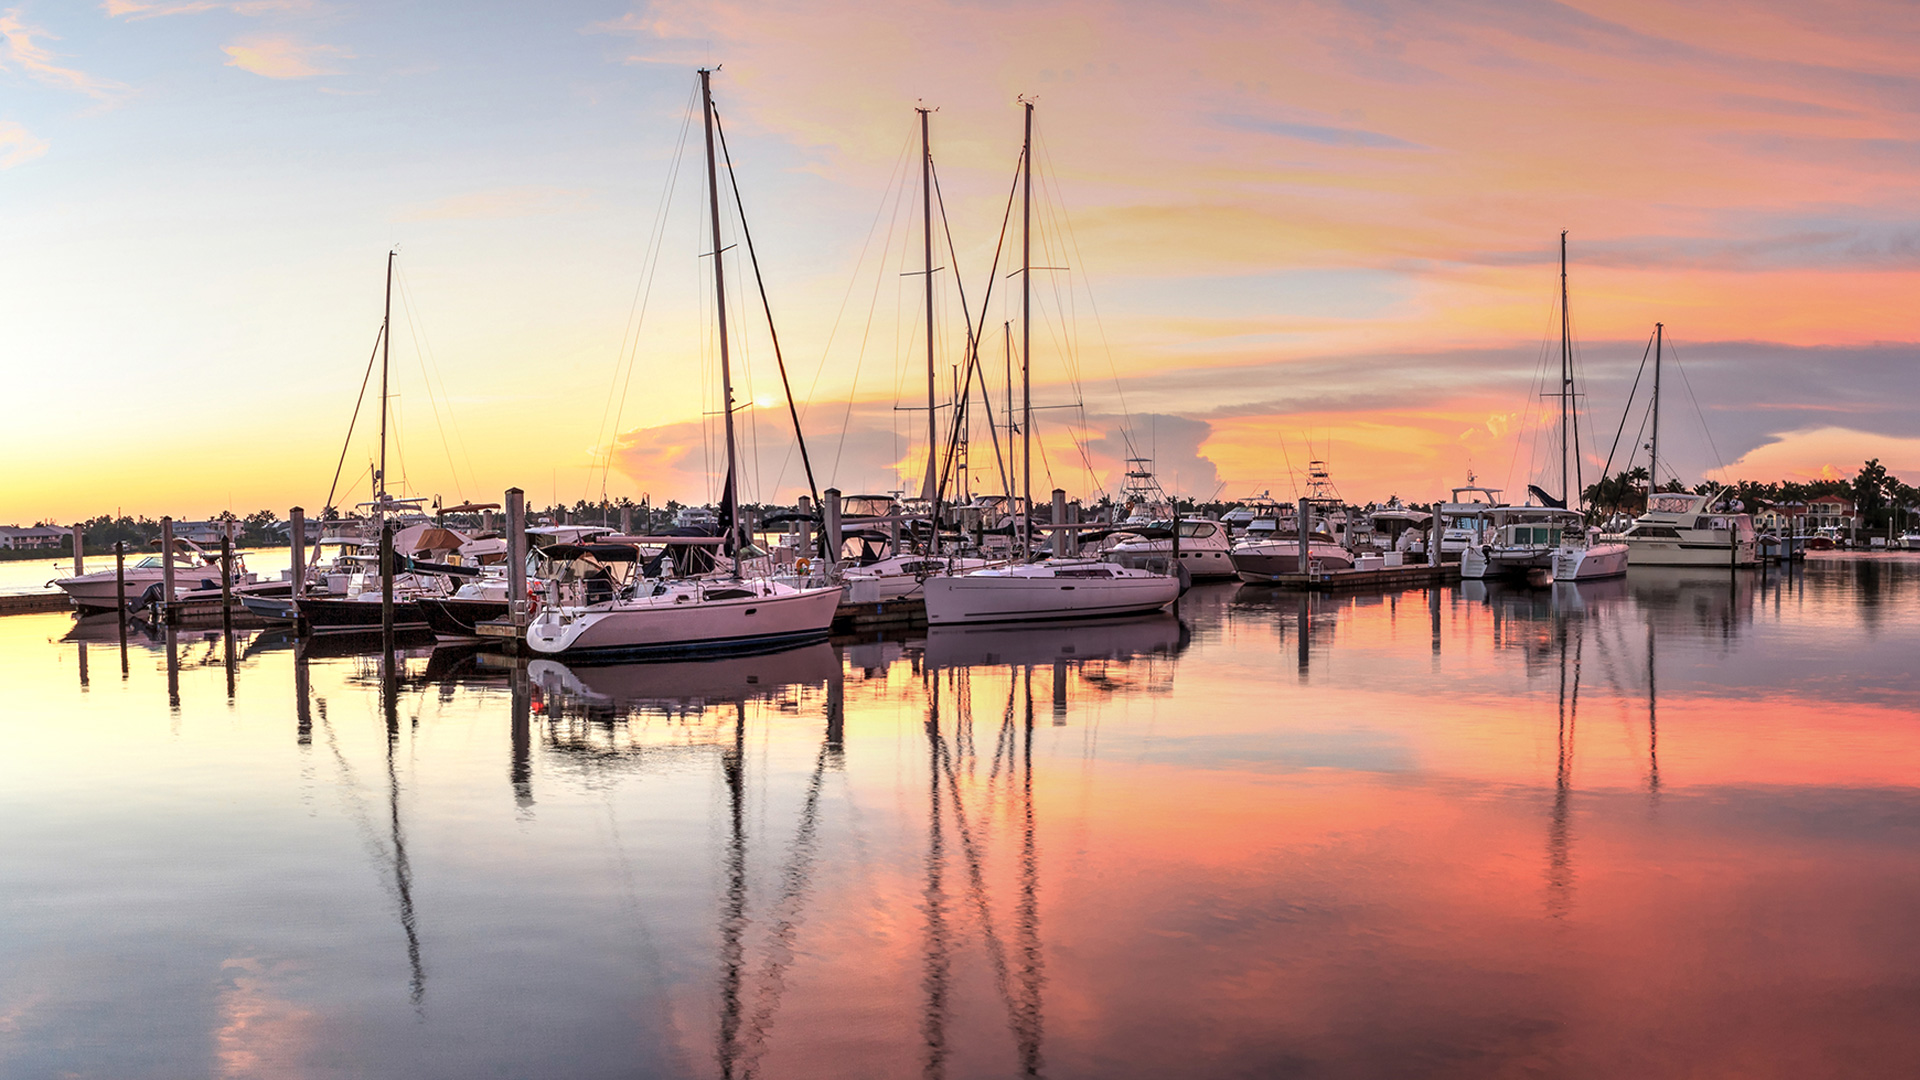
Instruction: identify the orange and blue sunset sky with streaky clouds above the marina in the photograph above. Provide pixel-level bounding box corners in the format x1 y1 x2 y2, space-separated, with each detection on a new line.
0 0 1920 523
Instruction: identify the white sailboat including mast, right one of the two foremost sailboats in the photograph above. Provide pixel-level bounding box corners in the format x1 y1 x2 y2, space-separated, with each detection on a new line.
924 102 1181 626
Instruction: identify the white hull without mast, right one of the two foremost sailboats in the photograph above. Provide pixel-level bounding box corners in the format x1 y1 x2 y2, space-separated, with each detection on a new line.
924 559 1181 626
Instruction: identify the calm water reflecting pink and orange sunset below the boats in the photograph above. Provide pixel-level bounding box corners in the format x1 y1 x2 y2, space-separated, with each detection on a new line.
0 557 1920 1078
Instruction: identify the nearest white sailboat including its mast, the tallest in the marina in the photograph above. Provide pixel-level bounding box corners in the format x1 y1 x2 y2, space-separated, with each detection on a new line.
526 67 841 655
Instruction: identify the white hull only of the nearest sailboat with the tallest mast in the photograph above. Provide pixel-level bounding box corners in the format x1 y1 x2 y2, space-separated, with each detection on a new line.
526 582 841 655
